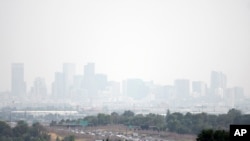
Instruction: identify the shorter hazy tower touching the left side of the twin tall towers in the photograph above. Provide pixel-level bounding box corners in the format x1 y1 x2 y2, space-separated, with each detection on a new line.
52 72 64 99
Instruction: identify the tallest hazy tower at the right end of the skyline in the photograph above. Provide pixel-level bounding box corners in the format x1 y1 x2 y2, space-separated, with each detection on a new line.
210 71 227 97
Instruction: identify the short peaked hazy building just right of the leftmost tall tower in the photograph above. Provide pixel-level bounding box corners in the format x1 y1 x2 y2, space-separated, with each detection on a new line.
31 77 47 97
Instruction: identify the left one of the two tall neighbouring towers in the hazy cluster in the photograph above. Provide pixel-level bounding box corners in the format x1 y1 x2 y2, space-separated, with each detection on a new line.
63 63 75 96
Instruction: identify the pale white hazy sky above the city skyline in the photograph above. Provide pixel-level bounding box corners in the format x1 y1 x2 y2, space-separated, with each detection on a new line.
0 0 250 93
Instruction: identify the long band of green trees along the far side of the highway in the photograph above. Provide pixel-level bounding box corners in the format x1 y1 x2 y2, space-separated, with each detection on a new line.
52 109 250 134
